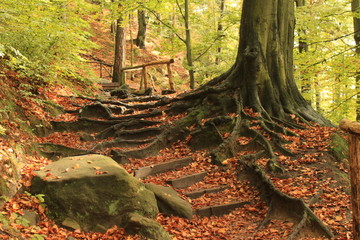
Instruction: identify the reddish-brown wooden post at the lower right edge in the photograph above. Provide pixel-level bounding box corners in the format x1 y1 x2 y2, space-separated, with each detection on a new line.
339 119 360 240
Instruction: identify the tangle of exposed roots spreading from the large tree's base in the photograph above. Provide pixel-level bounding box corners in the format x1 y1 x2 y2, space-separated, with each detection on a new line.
50 78 333 239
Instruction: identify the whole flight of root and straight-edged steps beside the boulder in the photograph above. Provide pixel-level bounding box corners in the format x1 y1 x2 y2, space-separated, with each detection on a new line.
40 93 248 220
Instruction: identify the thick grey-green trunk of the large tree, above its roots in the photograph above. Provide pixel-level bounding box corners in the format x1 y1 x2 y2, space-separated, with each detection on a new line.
228 0 326 123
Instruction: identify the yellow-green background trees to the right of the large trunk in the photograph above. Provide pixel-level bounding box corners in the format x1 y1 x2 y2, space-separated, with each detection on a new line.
294 0 359 122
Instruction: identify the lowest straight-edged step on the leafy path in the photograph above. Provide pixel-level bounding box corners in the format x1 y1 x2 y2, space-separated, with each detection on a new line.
194 202 249 217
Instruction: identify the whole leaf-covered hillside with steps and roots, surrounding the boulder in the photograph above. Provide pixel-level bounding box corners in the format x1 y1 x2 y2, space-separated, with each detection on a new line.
0 3 351 240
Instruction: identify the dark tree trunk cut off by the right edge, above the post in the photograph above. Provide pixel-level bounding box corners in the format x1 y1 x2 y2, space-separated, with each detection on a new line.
351 0 360 121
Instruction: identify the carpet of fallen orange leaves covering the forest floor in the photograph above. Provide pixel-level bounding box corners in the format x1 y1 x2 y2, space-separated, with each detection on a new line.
0 13 352 240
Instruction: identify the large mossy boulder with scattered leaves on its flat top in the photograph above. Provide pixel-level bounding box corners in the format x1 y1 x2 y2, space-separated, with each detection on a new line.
31 154 158 235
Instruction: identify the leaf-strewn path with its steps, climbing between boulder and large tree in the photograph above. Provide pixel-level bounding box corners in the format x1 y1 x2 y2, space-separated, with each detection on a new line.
39 91 346 240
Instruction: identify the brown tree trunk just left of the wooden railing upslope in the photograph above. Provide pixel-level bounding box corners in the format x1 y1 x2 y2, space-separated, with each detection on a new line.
112 18 126 86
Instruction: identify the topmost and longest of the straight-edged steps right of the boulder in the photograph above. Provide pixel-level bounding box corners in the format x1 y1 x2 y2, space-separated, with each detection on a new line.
135 157 193 178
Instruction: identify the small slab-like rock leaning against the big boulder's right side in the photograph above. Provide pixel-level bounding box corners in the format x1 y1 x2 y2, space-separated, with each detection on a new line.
145 183 193 219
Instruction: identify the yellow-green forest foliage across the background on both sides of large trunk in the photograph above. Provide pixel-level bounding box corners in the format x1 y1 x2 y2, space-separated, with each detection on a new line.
0 0 360 122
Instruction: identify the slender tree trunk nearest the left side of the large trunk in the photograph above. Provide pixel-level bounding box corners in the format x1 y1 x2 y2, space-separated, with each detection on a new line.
184 0 195 89
